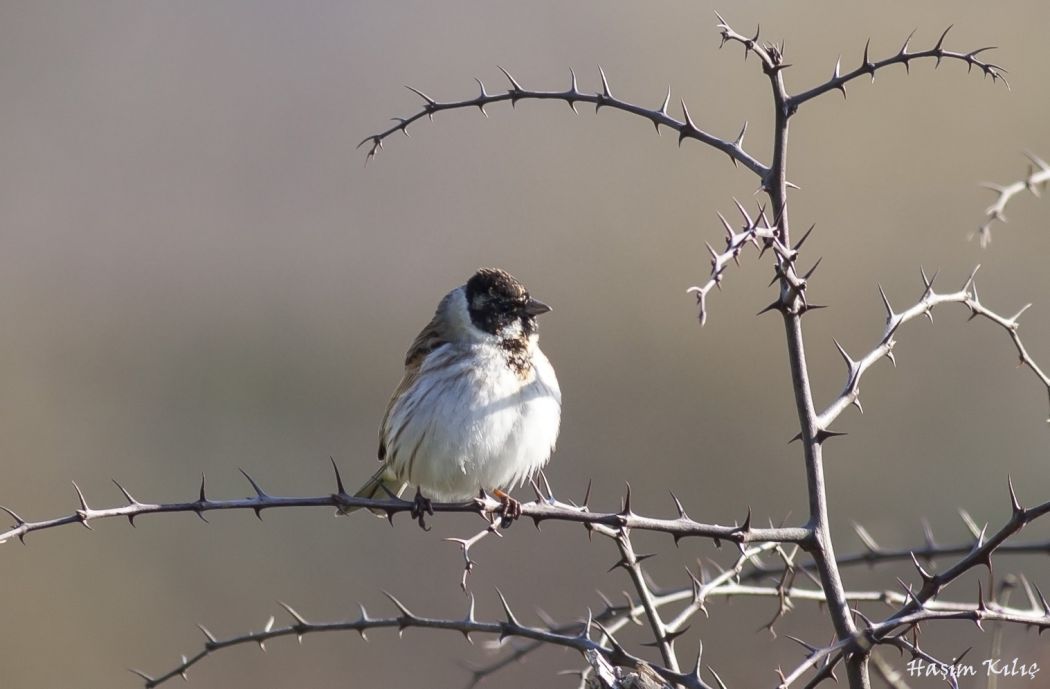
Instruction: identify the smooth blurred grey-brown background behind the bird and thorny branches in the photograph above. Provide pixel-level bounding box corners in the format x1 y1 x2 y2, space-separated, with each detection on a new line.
0 0 1050 689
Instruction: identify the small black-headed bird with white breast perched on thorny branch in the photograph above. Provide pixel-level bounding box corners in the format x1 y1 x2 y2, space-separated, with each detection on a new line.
347 268 562 524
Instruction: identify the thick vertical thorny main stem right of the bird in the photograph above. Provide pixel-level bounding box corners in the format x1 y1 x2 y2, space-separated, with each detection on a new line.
760 51 870 689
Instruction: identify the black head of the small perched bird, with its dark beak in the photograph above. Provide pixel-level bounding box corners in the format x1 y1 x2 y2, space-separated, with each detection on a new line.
466 268 550 337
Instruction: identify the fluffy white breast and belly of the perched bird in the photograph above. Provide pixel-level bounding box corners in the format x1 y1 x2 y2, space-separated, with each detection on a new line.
384 341 562 500
